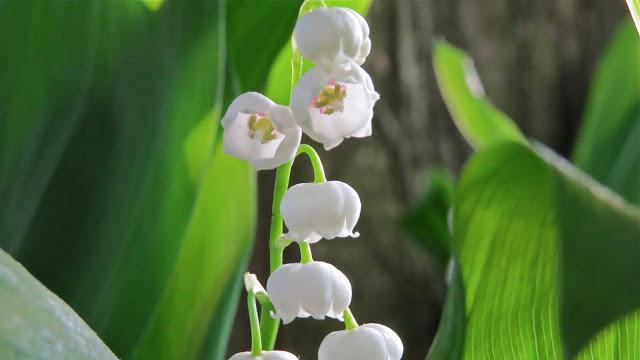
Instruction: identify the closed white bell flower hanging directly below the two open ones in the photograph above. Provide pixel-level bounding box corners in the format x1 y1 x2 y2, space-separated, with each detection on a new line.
280 181 361 243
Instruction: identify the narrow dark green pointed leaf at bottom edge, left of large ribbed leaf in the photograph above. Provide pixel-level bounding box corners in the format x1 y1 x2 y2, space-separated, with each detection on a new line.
427 258 466 360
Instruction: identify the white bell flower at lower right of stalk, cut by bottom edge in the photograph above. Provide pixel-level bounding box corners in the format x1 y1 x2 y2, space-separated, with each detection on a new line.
318 324 404 360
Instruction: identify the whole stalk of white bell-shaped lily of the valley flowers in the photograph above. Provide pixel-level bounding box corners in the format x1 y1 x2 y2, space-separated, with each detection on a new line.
222 8 403 360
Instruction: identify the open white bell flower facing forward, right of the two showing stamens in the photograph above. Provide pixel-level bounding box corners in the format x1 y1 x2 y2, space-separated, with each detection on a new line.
291 65 380 150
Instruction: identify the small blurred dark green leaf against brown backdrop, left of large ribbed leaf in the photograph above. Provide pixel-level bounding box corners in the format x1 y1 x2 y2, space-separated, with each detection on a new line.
400 170 453 265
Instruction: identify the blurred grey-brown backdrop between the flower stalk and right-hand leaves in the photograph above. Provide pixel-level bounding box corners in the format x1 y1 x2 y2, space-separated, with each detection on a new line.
231 0 628 359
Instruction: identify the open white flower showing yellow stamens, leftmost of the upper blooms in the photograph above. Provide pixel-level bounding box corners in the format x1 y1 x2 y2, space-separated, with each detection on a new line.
222 92 302 170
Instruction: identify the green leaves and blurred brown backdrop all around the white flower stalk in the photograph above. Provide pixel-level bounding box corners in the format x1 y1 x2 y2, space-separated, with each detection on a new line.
0 0 640 359
